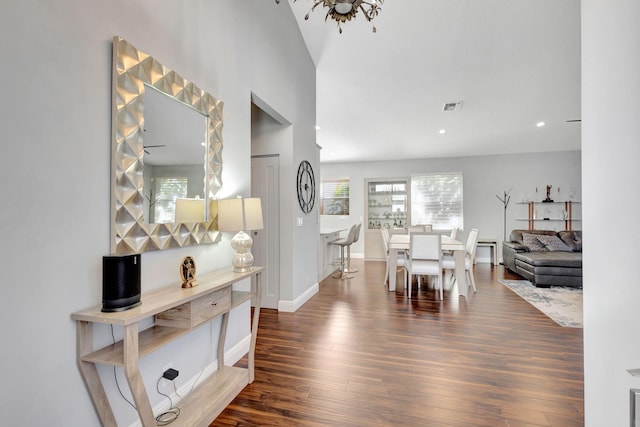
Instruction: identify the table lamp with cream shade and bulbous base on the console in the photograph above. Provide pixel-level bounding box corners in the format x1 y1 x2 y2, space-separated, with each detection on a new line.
218 197 263 273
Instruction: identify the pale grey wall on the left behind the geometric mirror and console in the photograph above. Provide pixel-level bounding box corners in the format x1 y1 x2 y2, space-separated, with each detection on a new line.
0 0 315 426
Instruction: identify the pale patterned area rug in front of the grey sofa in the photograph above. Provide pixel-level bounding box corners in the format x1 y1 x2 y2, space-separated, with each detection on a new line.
500 280 582 328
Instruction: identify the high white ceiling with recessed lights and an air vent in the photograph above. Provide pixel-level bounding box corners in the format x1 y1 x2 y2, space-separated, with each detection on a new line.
281 0 581 162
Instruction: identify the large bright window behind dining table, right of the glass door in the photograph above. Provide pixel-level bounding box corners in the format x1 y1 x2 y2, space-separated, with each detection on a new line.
411 172 463 230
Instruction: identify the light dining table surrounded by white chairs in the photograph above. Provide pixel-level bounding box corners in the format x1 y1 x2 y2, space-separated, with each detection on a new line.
389 234 469 298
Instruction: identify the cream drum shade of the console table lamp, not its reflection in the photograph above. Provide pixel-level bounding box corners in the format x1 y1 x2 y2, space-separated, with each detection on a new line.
218 197 263 231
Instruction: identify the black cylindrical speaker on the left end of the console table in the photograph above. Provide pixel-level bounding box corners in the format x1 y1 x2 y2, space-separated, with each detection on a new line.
102 254 140 312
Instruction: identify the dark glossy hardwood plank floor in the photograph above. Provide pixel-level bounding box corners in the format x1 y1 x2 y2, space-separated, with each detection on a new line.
211 260 584 427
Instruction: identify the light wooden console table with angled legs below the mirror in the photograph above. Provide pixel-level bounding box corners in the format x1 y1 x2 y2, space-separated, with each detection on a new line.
71 267 264 427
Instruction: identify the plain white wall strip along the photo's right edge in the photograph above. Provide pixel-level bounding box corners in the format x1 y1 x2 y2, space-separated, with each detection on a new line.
582 0 640 427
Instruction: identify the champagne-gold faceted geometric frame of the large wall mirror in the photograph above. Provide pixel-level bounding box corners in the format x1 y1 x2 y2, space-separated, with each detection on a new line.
111 36 223 254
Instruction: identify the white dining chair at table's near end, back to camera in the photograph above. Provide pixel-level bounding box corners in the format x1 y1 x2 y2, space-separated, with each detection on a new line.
406 232 444 300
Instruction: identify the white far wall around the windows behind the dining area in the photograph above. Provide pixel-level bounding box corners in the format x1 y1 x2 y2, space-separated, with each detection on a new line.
320 151 582 262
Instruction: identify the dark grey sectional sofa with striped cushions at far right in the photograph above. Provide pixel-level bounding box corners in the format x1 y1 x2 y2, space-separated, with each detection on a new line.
502 230 582 288
